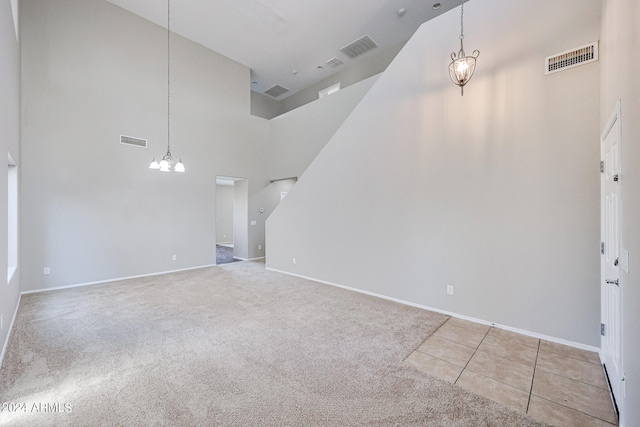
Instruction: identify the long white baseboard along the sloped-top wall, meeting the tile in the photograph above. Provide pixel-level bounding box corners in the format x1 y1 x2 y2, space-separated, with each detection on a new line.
266 267 600 354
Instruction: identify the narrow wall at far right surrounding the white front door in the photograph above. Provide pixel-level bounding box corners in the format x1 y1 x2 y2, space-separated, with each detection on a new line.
600 0 640 426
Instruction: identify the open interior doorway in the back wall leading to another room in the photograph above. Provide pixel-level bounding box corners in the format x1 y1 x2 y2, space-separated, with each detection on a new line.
216 176 248 265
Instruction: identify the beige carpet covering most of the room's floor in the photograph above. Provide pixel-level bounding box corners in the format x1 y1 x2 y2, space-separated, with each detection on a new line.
0 262 542 426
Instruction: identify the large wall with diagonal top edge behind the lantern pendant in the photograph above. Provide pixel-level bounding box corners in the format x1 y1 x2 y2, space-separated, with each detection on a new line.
267 0 600 346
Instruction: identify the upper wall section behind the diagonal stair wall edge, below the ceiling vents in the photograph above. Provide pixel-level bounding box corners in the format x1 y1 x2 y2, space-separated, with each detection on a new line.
268 76 379 181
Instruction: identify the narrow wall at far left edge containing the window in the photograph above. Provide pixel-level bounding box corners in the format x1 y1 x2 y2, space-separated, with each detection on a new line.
0 0 21 365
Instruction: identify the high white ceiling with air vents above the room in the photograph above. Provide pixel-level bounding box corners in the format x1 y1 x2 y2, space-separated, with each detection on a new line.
108 0 460 99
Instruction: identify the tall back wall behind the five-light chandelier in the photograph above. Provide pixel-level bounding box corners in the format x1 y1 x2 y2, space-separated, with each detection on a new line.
21 0 269 290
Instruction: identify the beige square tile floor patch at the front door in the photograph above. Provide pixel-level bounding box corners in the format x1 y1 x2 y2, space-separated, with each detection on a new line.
405 317 618 427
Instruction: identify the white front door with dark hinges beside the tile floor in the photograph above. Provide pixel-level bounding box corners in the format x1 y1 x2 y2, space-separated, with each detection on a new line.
600 104 623 412
